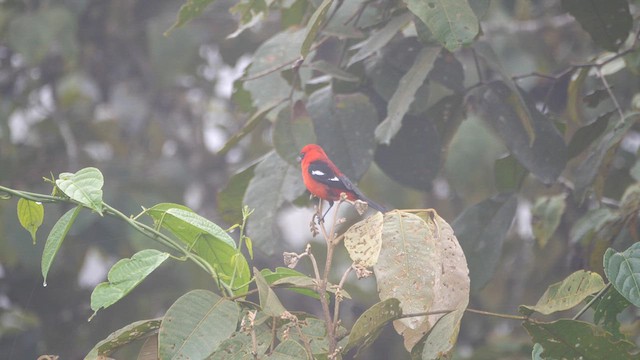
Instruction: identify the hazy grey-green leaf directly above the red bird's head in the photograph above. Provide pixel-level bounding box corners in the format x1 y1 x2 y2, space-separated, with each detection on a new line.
272 101 316 166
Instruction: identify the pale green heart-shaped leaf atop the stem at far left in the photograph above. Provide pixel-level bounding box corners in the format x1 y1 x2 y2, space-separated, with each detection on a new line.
56 167 104 215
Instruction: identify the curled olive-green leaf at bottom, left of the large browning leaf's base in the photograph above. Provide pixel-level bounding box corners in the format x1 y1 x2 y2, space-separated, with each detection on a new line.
344 298 402 353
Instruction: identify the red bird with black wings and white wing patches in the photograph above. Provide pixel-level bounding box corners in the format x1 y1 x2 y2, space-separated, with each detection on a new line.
298 144 386 218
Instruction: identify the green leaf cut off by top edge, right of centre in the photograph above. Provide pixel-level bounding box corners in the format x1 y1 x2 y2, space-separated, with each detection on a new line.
405 0 479 52
